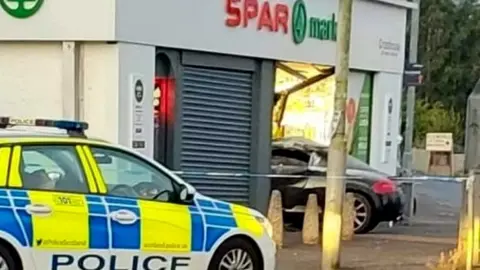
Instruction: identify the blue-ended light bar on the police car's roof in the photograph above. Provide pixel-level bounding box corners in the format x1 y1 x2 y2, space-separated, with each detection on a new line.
0 117 88 136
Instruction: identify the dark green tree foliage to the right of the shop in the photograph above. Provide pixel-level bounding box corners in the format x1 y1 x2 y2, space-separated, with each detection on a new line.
415 0 480 147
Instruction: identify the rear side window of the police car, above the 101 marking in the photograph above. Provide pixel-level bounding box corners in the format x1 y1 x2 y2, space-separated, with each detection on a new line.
19 145 88 193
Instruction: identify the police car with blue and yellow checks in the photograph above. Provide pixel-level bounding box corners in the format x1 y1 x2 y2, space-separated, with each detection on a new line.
0 117 276 270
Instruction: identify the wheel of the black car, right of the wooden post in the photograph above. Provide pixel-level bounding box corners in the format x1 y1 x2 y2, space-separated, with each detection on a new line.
353 193 378 234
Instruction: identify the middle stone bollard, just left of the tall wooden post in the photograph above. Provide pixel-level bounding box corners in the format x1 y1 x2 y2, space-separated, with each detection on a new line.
302 194 320 245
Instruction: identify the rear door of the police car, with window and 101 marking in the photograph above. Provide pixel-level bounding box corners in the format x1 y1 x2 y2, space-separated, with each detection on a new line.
8 144 108 270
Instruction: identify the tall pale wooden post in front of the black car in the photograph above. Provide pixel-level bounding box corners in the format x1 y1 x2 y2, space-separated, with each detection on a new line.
322 0 353 270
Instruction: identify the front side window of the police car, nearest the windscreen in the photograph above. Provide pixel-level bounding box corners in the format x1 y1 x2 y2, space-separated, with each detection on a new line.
91 147 175 201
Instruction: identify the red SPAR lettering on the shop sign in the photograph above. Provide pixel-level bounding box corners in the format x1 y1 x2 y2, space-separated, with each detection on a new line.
225 0 289 34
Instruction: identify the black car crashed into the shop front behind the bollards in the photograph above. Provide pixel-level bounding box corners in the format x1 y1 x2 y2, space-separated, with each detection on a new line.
271 138 404 233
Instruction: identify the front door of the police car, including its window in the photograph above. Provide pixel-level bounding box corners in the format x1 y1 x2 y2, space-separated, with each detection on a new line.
86 146 197 270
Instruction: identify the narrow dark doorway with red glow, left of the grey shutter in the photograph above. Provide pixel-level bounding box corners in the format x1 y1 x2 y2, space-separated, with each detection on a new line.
153 54 175 167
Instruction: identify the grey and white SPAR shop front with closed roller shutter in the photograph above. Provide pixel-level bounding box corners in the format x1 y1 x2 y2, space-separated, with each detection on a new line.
0 0 412 209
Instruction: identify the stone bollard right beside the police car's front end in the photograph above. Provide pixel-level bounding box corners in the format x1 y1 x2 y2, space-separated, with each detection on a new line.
267 190 283 248
